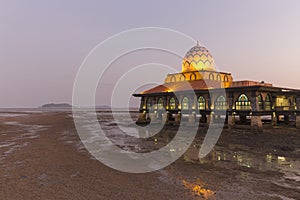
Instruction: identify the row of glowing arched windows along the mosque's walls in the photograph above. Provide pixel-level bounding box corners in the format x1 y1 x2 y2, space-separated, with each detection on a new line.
146 94 271 110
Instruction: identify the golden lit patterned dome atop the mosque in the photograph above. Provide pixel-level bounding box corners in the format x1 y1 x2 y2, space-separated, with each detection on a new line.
182 43 215 72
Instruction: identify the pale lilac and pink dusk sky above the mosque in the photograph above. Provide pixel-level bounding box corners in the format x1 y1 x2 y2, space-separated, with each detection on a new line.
0 0 300 108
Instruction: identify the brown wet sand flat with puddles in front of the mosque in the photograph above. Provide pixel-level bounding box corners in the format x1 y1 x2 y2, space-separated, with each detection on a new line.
0 112 300 199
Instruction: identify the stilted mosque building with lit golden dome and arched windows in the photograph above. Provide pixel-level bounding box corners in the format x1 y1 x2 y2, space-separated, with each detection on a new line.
133 43 300 128
